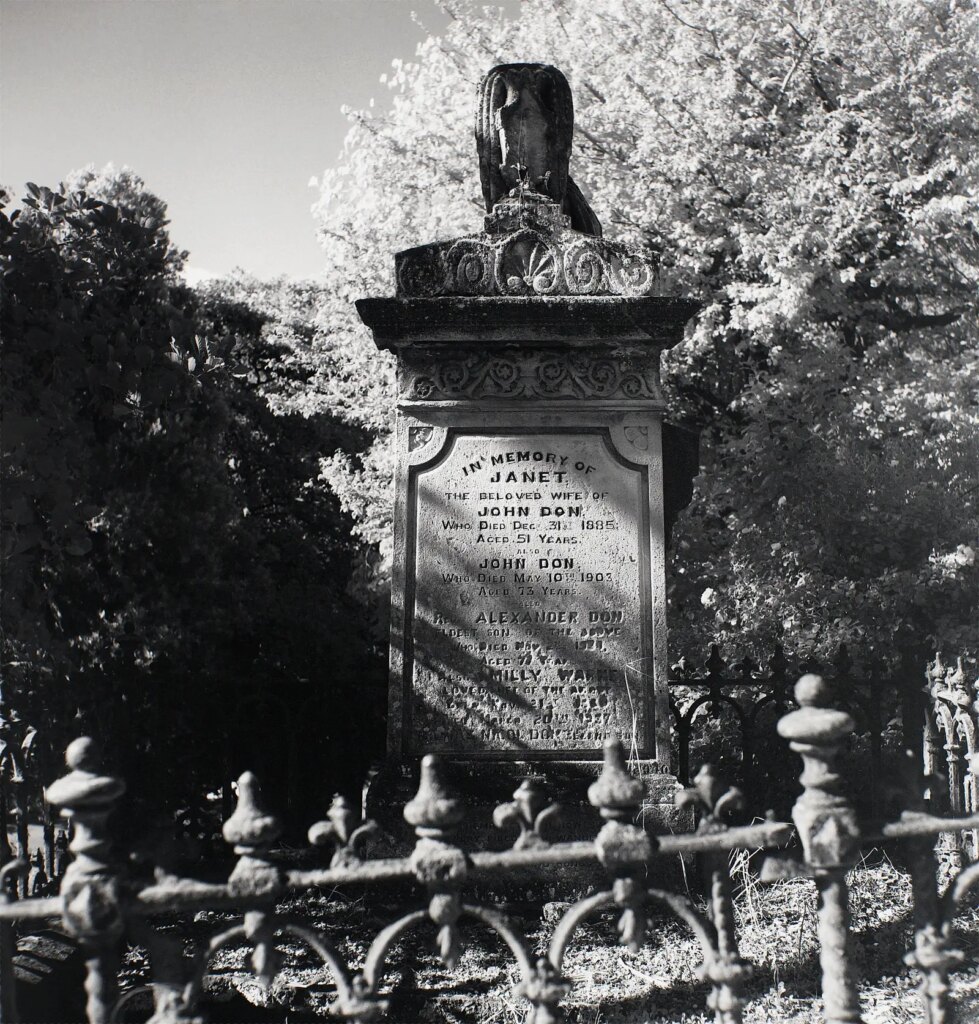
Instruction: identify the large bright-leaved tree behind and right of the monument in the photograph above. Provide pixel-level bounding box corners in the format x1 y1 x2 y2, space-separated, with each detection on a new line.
317 0 979 656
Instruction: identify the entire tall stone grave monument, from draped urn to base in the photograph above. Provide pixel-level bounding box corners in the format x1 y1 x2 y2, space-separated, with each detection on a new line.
357 65 696 839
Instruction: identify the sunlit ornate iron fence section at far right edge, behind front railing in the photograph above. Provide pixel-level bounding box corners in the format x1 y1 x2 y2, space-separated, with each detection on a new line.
925 653 979 867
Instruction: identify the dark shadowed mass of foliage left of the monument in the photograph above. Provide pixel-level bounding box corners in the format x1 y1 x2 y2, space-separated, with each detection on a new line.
0 169 377 831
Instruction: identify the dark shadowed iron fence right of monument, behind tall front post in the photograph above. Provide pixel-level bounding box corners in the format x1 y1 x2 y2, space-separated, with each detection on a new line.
670 645 923 815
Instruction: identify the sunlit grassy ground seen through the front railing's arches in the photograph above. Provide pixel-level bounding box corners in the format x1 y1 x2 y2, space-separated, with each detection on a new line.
111 850 979 1024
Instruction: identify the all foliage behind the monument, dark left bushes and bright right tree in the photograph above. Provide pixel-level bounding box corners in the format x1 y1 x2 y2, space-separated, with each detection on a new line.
0 0 979 831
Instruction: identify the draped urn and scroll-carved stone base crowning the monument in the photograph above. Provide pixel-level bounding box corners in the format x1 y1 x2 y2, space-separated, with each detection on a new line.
394 63 661 298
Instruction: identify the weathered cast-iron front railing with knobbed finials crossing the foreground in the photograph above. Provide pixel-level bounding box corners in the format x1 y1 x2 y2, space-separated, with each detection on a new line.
0 676 979 1024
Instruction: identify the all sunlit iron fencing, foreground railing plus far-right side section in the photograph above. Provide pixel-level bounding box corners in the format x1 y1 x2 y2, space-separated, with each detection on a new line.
0 658 979 1022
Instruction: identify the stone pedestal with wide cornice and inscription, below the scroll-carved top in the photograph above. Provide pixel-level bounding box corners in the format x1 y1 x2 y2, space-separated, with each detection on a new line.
357 296 694 845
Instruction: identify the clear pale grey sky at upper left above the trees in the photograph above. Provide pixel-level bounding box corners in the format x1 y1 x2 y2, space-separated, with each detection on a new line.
0 0 481 281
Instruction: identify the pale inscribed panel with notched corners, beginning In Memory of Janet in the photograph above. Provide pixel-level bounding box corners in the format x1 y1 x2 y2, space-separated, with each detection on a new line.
405 428 652 756
